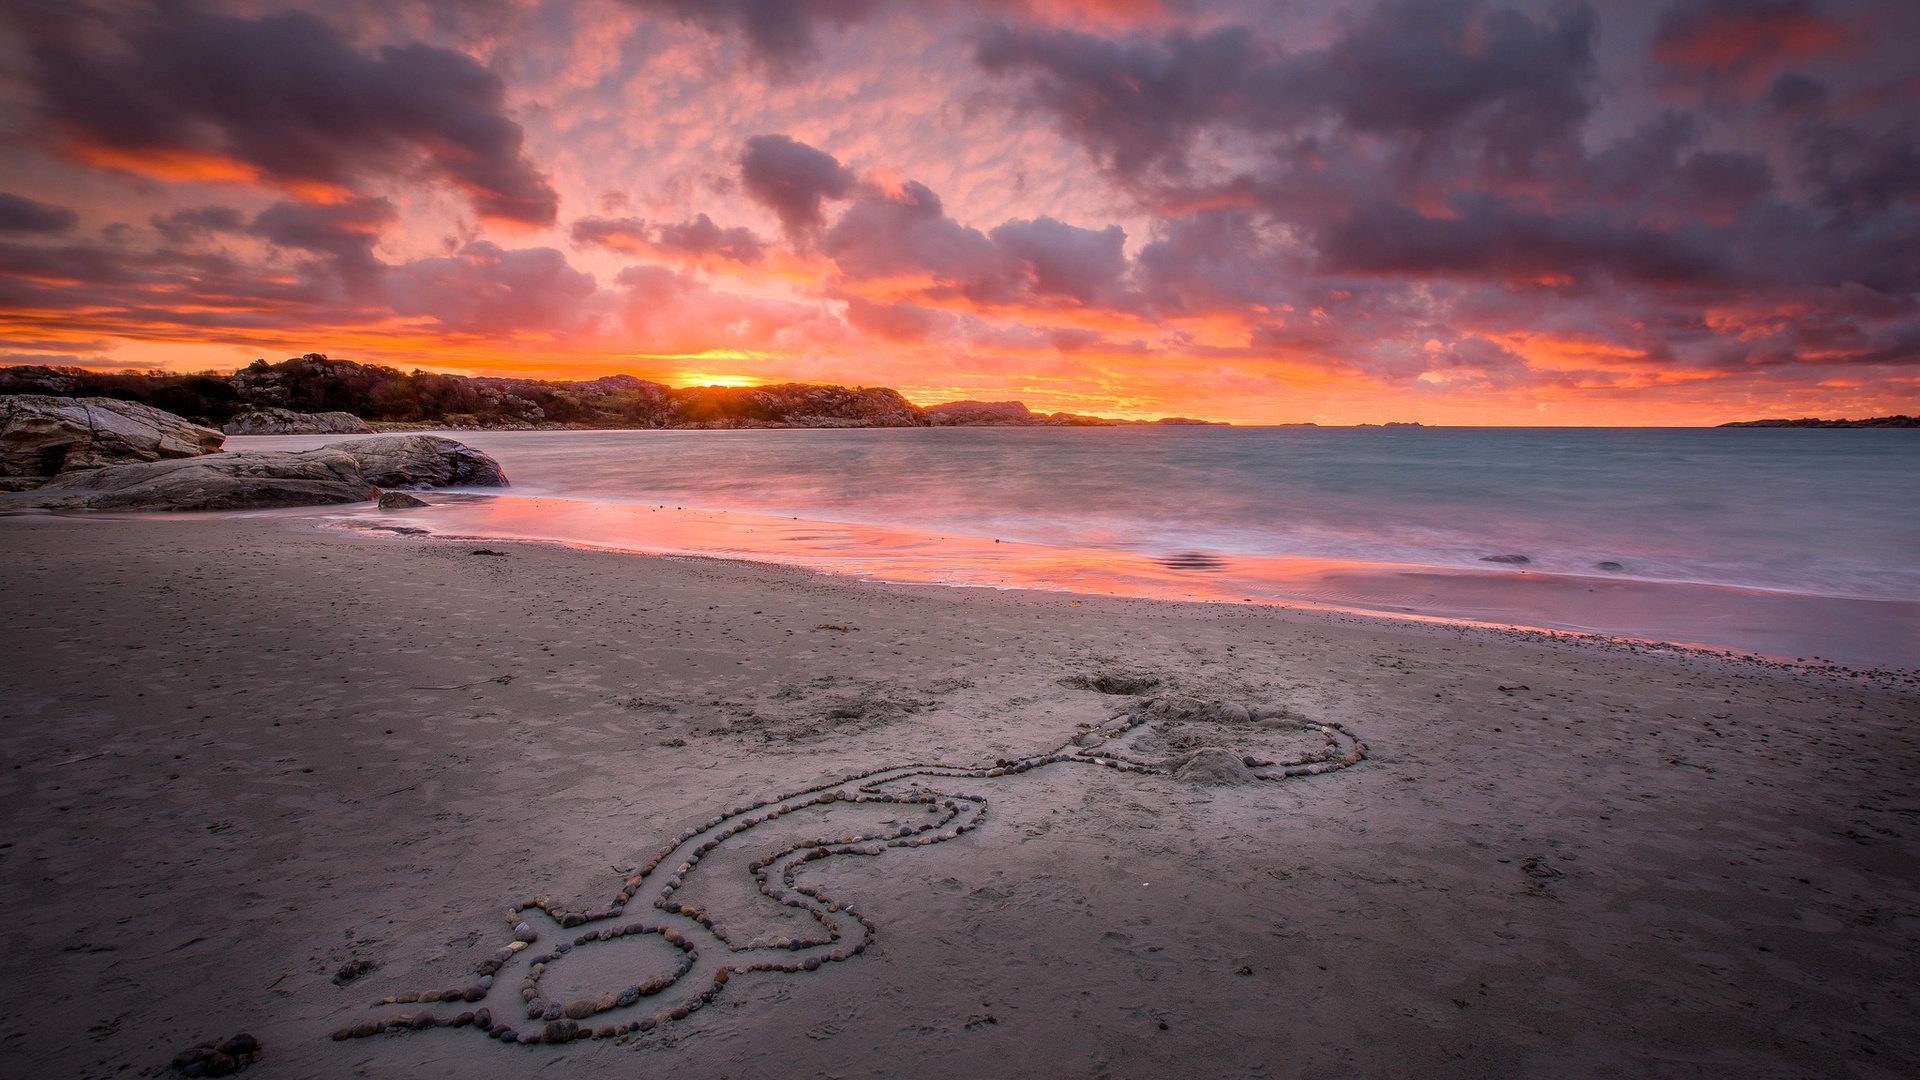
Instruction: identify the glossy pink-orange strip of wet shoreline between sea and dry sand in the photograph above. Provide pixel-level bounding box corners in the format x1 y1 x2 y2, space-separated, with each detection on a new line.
342 496 1920 667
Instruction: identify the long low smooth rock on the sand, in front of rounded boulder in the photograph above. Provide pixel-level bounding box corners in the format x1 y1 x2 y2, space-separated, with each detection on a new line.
0 434 507 511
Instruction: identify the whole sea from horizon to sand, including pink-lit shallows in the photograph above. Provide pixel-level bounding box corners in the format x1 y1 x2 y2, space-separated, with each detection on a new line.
228 427 1920 667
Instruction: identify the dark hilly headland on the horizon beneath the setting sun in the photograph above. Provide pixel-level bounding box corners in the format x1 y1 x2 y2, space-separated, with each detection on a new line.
0 352 1219 434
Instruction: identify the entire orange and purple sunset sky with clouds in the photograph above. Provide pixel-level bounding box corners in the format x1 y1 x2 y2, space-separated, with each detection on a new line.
0 0 1920 425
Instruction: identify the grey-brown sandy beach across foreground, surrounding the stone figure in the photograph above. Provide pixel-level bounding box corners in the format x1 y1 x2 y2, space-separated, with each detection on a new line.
0 515 1920 1078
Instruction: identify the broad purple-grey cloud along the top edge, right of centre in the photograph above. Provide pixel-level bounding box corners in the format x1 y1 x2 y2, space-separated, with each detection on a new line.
975 0 1594 179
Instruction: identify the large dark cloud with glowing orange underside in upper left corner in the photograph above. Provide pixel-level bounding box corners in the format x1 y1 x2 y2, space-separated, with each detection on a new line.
23 4 559 225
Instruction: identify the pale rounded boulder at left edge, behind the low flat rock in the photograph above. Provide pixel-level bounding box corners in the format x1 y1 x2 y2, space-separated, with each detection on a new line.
0 394 225 477
